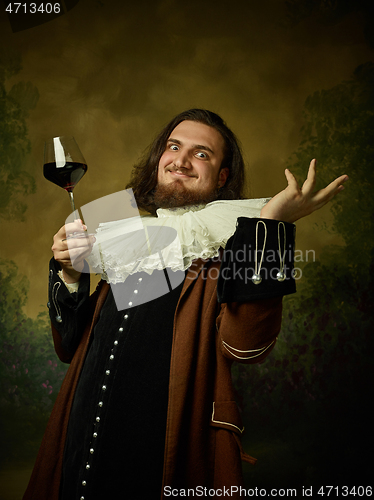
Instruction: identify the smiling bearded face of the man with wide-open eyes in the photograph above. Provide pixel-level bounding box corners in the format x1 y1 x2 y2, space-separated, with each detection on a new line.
155 120 229 208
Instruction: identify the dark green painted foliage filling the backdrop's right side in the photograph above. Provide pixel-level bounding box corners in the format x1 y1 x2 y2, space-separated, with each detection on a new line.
234 63 374 484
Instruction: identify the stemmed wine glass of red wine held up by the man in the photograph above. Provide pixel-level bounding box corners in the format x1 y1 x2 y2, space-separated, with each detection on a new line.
43 137 87 215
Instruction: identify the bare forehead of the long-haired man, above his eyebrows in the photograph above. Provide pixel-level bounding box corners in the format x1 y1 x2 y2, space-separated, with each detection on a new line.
169 120 225 155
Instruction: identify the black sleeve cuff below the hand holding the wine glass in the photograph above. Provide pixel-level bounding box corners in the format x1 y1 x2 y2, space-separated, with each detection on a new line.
48 258 90 353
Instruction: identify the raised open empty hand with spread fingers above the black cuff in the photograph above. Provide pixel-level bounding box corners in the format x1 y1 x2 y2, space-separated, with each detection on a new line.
261 160 348 222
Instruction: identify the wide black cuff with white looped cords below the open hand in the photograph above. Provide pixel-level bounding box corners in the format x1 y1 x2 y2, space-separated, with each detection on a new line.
217 217 296 303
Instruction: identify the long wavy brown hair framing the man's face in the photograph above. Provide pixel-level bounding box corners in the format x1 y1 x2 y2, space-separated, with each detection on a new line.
126 109 245 214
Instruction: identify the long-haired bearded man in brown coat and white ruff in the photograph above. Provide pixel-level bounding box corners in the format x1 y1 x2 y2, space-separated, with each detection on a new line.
24 109 347 500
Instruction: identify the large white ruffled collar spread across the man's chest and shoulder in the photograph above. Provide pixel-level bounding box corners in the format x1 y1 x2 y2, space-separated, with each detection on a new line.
87 198 269 283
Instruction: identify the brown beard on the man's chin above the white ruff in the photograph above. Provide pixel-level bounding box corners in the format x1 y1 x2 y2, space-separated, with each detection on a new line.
153 180 218 208
